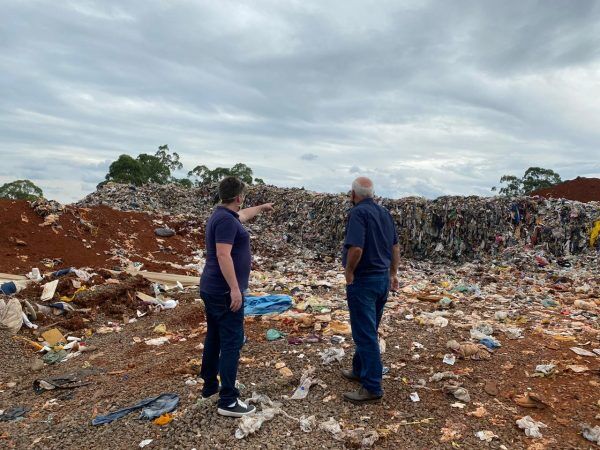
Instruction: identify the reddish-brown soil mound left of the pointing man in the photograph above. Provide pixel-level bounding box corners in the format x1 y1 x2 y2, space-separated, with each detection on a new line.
0 200 204 275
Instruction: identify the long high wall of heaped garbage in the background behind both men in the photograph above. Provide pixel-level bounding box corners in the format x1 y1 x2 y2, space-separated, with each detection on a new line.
78 183 600 260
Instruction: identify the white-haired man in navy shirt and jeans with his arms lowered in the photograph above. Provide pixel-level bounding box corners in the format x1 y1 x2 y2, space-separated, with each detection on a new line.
342 177 400 404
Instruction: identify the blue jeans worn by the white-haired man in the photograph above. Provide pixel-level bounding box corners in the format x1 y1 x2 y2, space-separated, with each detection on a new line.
346 274 390 395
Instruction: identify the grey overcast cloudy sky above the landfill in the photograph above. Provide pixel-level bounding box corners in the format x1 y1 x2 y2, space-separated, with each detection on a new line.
0 0 600 202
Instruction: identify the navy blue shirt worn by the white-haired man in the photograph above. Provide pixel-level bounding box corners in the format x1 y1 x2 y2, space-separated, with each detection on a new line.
342 198 398 277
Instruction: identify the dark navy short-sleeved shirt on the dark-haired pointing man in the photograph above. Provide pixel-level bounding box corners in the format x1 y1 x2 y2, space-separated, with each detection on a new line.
200 206 252 294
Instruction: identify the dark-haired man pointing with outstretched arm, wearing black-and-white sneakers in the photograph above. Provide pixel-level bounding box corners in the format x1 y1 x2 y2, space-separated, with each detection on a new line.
200 177 273 417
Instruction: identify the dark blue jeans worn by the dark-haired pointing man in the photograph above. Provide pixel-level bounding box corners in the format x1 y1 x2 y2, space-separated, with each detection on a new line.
200 292 244 407
